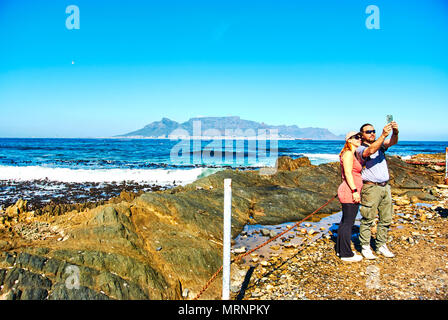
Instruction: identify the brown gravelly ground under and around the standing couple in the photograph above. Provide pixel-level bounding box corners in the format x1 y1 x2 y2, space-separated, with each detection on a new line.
233 188 448 300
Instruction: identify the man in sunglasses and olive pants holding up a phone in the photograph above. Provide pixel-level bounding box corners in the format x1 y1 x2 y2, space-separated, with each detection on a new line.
356 121 398 259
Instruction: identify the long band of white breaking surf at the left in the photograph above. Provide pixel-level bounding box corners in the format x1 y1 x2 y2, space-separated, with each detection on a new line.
0 166 216 185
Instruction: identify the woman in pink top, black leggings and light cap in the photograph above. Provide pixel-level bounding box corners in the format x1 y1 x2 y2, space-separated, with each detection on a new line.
336 131 362 261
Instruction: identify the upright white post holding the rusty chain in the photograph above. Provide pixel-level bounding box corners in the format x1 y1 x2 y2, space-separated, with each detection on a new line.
222 179 232 300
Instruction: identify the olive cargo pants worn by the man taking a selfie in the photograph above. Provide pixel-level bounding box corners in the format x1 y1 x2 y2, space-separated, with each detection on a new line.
359 184 393 249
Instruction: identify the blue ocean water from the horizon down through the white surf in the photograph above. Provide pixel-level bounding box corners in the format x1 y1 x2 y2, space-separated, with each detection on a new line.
0 138 448 185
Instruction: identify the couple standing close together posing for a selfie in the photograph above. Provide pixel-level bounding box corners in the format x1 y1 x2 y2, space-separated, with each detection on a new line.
336 121 398 262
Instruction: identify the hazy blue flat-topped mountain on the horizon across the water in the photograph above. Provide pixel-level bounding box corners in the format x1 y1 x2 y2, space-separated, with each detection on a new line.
115 117 343 140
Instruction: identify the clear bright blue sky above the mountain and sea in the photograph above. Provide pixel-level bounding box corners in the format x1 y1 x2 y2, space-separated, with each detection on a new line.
0 0 448 141
